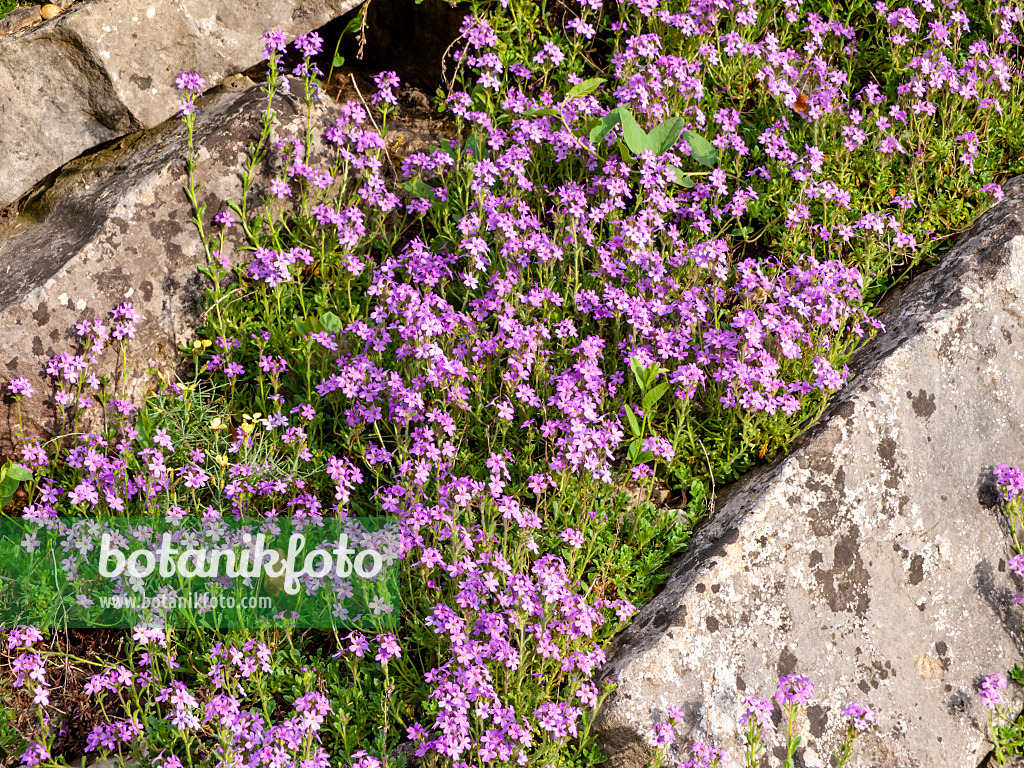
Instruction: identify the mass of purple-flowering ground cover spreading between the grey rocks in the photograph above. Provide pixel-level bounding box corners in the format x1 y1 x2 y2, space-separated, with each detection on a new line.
0 0 1024 768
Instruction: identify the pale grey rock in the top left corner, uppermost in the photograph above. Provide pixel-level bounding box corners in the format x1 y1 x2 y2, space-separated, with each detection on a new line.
0 0 362 207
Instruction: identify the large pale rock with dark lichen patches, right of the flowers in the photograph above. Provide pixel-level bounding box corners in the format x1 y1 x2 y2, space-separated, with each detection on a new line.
597 177 1024 768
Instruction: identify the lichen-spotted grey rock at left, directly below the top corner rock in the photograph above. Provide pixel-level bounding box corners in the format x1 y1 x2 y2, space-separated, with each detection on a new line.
0 87 340 452
